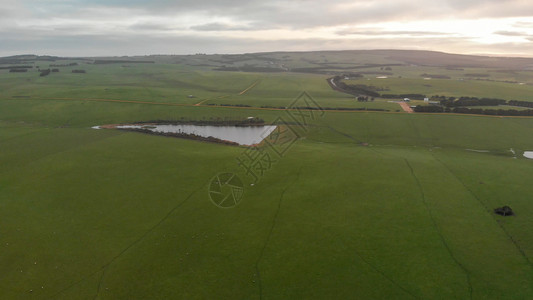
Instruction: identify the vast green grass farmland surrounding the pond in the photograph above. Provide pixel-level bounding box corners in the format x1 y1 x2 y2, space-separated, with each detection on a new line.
0 51 533 299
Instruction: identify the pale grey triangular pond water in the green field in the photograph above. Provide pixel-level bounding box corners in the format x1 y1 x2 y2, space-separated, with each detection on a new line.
116 125 277 146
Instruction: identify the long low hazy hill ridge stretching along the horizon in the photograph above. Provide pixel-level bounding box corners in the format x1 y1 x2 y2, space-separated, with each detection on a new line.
4 50 533 73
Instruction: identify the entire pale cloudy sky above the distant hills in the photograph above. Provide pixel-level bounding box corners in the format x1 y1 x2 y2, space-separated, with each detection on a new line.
0 0 533 56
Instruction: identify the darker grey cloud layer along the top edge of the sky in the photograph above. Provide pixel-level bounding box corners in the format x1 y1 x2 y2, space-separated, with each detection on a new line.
82 0 533 28
